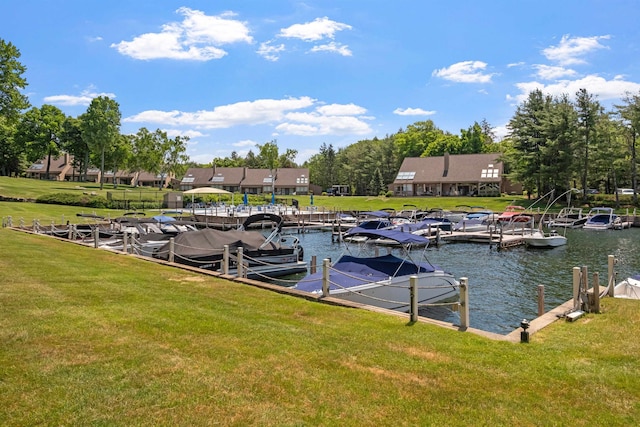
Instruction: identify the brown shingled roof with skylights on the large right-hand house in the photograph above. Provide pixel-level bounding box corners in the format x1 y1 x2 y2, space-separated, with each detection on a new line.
394 153 503 184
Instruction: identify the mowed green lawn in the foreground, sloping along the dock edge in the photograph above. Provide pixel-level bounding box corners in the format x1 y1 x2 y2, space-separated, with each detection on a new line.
0 229 640 426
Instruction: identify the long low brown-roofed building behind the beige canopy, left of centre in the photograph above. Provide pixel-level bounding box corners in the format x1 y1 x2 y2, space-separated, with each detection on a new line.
180 166 309 196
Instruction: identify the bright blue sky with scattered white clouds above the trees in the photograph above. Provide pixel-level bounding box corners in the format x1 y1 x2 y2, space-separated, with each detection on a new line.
5 0 640 163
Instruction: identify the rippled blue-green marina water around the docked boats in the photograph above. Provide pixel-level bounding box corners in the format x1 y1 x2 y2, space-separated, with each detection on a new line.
286 228 640 334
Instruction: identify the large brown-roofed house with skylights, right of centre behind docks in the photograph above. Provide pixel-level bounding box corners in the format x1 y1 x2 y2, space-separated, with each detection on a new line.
389 153 511 196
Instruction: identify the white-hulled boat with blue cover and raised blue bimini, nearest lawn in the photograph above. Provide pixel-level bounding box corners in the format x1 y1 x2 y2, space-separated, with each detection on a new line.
294 230 459 311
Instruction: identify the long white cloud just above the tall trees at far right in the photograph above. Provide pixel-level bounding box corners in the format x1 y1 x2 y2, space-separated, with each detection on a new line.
507 75 640 103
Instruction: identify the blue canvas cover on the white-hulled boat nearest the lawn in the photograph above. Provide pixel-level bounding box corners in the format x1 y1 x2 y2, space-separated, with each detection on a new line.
294 254 436 292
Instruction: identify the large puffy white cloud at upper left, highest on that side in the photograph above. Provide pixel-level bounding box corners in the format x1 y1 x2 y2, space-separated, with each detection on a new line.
111 7 253 61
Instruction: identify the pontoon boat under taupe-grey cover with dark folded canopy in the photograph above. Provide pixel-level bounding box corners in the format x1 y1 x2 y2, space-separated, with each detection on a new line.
154 213 308 279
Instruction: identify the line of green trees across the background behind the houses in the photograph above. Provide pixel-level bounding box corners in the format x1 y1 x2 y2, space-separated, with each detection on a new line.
0 39 640 202
